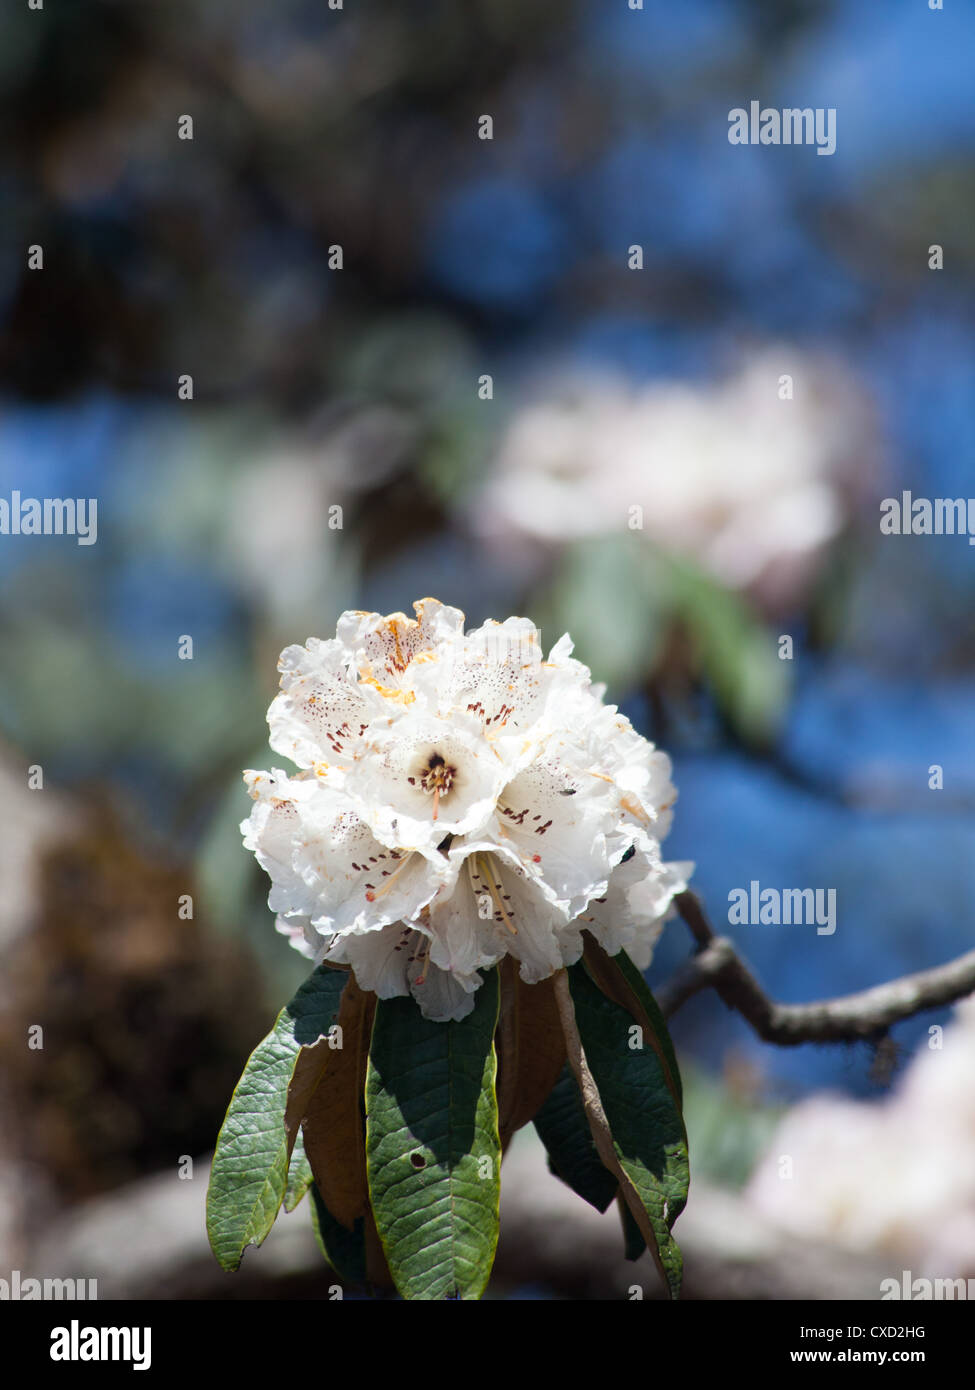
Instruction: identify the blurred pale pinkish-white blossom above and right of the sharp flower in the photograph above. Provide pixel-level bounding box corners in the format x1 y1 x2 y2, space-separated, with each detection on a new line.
470 348 876 609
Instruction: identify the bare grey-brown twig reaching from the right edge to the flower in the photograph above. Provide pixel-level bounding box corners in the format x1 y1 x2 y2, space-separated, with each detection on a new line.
656 892 975 1047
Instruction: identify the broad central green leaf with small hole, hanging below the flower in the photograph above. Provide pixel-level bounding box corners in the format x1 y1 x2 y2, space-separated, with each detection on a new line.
366 969 501 1300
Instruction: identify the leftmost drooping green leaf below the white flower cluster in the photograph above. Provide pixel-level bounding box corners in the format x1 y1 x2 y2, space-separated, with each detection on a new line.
206 966 348 1269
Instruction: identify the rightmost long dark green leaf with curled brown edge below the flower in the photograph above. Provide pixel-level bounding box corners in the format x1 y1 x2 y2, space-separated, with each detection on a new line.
567 960 690 1298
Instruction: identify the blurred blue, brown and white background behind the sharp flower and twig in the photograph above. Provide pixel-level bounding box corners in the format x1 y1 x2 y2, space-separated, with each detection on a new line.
0 0 975 1298
